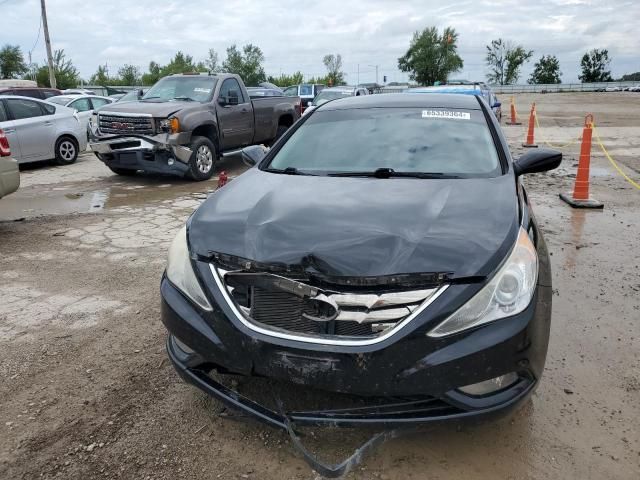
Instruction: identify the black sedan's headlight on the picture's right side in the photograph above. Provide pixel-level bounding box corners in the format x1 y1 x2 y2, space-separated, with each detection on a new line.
427 227 538 337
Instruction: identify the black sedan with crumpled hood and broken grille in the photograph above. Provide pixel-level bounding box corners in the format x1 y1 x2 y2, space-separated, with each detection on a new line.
161 94 562 428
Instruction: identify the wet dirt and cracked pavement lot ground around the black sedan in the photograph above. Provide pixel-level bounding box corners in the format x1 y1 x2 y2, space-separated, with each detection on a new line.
0 92 640 480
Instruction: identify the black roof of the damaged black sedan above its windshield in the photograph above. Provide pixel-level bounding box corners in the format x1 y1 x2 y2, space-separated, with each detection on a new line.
318 93 480 110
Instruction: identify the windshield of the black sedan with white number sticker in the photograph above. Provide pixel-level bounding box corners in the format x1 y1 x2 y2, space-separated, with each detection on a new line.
267 108 502 177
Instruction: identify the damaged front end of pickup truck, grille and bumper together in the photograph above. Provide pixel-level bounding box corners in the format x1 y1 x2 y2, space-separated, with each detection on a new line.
89 111 192 175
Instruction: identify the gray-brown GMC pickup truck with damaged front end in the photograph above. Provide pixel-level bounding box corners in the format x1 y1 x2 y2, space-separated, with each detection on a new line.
89 73 301 180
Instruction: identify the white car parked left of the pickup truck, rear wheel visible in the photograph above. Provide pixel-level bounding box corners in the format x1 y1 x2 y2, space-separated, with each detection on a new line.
0 95 87 165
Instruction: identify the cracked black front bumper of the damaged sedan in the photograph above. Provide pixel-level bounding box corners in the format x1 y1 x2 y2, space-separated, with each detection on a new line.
161 262 551 428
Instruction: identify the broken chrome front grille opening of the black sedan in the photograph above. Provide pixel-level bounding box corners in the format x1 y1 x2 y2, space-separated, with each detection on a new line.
219 271 437 339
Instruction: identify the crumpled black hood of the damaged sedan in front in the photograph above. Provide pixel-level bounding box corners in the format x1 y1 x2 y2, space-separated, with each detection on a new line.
188 168 519 277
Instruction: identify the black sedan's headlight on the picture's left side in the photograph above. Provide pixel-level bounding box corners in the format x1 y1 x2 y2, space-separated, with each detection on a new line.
167 227 211 310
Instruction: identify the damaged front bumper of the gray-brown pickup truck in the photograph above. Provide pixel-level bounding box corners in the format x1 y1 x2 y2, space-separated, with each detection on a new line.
89 126 193 175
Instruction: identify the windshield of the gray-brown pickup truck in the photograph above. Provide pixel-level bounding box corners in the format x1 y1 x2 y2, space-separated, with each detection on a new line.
142 75 216 103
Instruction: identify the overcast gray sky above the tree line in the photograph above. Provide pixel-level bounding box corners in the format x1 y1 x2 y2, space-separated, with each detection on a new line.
0 0 640 83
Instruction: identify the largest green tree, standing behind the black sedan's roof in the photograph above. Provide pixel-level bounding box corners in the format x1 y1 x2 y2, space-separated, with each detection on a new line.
398 27 464 85
